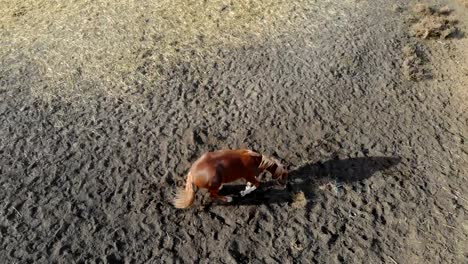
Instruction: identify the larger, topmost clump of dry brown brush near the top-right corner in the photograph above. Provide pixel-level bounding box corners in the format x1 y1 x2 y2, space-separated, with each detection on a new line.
411 4 462 39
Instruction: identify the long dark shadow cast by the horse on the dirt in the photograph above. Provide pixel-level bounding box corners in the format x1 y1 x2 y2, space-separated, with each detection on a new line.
220 157 401 205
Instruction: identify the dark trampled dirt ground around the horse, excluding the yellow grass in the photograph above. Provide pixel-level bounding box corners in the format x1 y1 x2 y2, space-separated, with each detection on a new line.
0 0 468 264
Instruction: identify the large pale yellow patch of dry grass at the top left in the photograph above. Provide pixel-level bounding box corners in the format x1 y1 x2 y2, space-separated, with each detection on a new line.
0 0 309 100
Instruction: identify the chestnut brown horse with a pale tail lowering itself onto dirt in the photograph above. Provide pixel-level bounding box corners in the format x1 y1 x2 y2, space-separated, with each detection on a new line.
173 149 288 208
